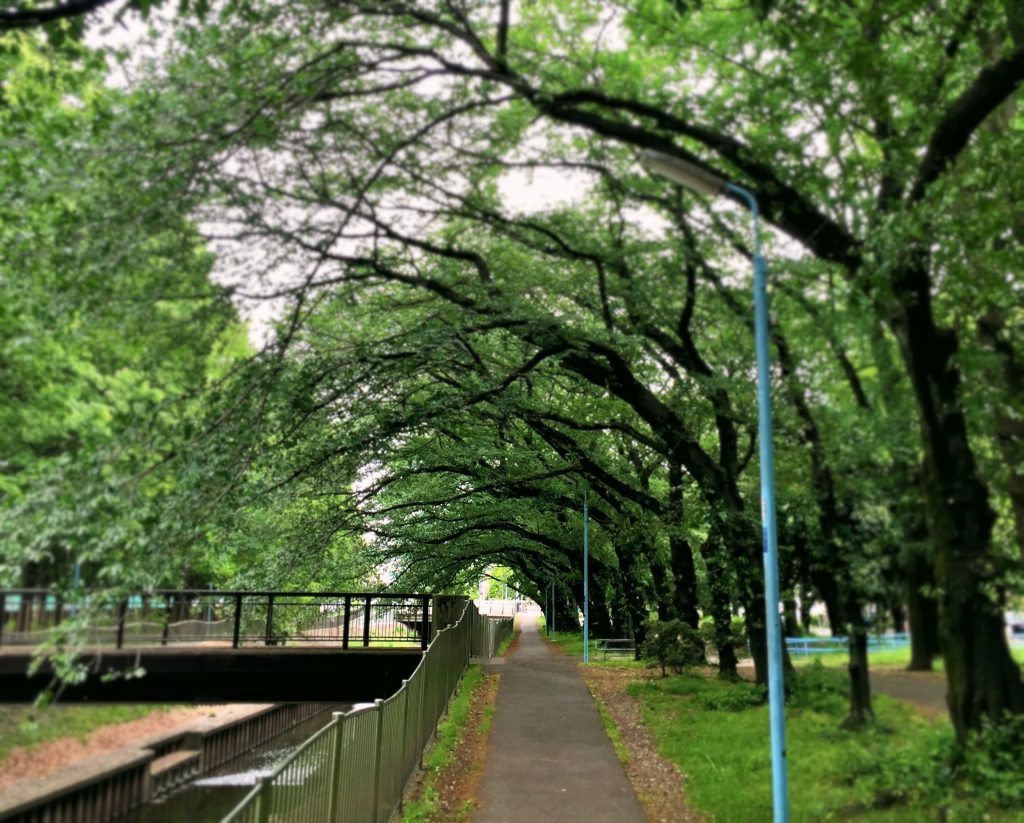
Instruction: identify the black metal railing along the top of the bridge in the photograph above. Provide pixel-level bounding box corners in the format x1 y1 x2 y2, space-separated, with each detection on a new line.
0 589 431 649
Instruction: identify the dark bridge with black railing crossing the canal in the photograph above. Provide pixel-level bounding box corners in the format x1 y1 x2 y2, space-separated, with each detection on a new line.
0 589 466 703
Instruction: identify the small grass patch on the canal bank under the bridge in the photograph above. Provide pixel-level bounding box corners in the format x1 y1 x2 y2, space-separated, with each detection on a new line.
0 705 168 761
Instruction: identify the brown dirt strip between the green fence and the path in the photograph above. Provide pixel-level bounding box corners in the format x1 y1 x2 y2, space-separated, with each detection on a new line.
407 671 499 823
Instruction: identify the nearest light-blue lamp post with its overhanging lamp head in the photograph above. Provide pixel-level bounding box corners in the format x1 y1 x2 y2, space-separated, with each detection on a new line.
640 150 790 823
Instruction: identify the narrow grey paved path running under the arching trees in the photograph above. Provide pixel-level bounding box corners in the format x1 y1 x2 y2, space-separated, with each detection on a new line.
473 614 646 823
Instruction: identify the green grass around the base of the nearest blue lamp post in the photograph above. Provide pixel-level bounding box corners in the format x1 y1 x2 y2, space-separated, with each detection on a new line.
630 666 1024 823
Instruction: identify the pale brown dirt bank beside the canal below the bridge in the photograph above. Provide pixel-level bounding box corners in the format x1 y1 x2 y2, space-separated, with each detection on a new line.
0 703 265 790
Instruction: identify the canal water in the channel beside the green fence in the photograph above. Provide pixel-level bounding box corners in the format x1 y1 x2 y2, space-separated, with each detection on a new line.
117 703 350 823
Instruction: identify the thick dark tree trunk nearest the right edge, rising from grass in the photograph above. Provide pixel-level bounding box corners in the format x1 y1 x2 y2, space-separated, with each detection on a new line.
891 260 1024 744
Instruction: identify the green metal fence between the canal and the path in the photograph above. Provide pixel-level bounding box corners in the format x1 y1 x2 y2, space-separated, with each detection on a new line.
222 602 512 823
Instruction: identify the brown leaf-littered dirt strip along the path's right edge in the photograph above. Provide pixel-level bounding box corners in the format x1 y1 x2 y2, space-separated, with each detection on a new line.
580 665 705 823
